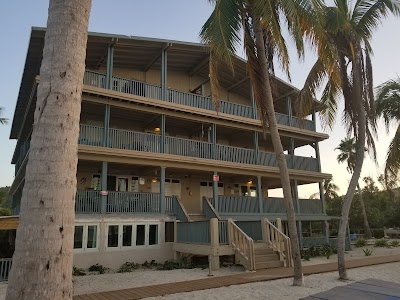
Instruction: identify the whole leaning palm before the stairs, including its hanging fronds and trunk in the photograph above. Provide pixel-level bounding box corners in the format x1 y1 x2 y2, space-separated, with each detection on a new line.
200 0 307 285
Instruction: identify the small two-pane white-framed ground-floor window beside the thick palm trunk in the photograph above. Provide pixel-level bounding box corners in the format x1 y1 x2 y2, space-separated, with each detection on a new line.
74 224 99 251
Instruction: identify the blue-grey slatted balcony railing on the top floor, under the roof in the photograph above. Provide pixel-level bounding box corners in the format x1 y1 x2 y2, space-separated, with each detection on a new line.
83 70 315 131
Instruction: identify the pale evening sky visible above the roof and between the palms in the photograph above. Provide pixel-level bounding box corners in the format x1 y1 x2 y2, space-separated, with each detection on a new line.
0 0 400 197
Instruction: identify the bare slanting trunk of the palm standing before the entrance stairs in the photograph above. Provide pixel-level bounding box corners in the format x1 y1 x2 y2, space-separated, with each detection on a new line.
254 20 304 286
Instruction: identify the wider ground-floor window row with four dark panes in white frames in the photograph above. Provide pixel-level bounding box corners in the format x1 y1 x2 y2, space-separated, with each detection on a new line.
107 222 160 250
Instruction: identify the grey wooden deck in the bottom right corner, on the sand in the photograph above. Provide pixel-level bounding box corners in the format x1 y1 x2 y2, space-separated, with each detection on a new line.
302 279 400 300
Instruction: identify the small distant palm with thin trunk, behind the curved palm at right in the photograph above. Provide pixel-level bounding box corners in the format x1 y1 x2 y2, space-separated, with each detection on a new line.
335 138 372 239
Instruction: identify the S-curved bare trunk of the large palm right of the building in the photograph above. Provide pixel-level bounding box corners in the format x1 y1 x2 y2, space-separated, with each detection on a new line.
338 55 367 280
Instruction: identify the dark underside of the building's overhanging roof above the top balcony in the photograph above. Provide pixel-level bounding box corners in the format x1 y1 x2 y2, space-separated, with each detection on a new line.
10 27 304 139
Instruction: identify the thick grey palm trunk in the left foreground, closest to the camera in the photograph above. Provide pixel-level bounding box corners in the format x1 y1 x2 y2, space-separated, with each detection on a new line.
6 0 91 300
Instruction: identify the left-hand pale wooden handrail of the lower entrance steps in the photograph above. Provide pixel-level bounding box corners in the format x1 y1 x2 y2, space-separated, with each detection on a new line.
228 219 256 271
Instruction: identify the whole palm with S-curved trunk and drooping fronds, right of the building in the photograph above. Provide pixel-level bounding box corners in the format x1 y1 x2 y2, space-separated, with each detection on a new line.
297 0 400 279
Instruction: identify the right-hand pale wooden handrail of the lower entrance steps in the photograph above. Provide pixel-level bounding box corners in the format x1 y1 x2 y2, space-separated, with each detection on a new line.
262 219 293 267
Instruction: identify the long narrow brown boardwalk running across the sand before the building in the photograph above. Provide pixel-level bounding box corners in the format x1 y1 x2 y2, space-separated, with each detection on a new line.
74 254 400 300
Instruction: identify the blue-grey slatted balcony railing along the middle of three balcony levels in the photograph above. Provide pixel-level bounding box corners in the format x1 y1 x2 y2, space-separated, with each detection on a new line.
79 124 318 172
